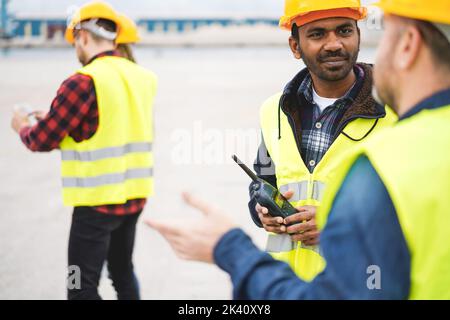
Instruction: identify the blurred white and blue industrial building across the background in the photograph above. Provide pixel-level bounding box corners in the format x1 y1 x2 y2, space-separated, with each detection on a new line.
0 0 380 47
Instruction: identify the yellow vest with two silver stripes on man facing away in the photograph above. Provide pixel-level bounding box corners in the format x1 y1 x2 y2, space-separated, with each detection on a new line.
60 56 157 206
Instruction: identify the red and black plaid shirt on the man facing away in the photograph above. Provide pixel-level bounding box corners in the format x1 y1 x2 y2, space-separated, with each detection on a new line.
20 51 146 215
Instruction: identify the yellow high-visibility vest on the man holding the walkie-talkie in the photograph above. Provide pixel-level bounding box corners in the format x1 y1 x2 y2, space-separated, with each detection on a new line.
260 94 397 281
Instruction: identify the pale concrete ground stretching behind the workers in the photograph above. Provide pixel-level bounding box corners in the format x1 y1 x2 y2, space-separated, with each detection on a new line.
0 46 373 299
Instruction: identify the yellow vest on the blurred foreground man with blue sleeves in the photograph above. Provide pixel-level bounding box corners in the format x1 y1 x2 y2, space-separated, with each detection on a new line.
317 105 450 300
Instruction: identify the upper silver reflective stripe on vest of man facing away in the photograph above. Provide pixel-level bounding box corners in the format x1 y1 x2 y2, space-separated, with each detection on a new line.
61 142 152 162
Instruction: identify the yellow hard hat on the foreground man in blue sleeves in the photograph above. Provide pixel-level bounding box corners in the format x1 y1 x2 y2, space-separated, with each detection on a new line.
375 0 450 24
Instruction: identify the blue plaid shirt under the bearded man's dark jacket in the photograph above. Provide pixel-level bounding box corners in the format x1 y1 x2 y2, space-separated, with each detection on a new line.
297 66 364 172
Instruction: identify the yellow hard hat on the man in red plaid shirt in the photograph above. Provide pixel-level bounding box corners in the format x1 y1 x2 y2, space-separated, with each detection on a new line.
65 1 121 44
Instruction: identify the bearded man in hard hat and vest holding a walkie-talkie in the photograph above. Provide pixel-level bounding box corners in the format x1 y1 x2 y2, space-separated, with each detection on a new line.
244 0 396 281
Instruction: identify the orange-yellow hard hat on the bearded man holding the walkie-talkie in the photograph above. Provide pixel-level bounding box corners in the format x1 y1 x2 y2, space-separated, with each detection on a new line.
280 0 367 30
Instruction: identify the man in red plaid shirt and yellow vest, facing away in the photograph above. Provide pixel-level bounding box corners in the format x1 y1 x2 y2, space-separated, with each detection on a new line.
12 1 157 299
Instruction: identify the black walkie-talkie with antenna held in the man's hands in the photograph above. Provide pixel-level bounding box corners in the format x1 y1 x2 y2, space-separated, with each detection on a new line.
232 155 297 219
